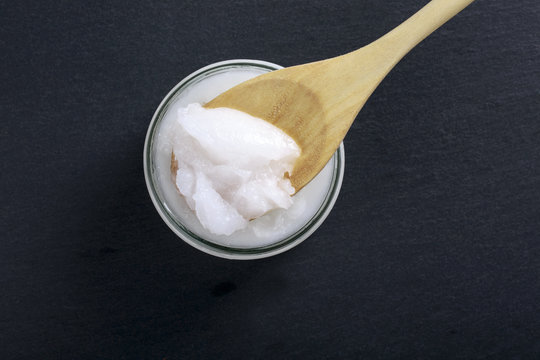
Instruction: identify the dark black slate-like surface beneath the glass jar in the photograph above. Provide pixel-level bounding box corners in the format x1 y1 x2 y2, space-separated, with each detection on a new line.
0 0 540 359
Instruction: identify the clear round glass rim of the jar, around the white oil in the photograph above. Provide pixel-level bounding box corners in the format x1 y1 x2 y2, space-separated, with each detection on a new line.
143 59 345 260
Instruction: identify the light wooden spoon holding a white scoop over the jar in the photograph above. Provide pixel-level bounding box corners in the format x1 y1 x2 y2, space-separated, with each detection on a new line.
205 0 474 191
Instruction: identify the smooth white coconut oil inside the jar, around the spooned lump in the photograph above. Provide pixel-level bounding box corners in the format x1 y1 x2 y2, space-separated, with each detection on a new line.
153 68 335 248
